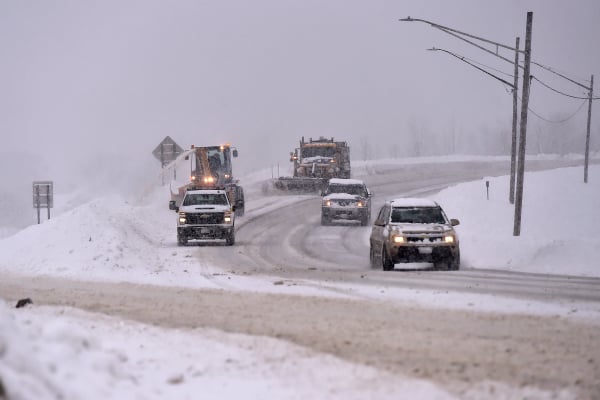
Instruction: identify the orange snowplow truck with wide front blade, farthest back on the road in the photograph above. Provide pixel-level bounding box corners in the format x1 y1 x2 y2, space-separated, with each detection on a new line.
274 136 350 192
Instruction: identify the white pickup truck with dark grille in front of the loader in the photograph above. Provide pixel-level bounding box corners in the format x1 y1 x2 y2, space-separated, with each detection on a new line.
169 189 235 246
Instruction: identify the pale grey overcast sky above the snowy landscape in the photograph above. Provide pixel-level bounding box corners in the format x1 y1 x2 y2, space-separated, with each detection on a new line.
0 0 600 179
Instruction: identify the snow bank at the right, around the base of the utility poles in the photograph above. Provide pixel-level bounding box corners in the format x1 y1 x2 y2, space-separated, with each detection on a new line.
431 166 600 276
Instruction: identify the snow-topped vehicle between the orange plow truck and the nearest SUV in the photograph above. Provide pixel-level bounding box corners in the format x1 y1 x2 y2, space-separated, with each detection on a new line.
321 178 371 226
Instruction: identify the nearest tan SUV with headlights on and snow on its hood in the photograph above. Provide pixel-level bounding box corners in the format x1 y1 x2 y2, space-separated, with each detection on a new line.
369 198 460 271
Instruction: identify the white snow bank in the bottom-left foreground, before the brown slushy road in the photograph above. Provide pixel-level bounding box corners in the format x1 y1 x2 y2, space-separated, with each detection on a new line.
0 301 454 400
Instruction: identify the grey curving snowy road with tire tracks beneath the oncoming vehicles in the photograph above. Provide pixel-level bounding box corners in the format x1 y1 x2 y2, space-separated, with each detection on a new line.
196 161 600 302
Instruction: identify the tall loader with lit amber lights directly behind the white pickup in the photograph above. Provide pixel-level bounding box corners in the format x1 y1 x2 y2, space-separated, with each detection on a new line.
169 144 244 217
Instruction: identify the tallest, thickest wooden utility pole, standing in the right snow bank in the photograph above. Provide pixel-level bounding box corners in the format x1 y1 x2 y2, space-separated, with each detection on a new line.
513 11 533 236
